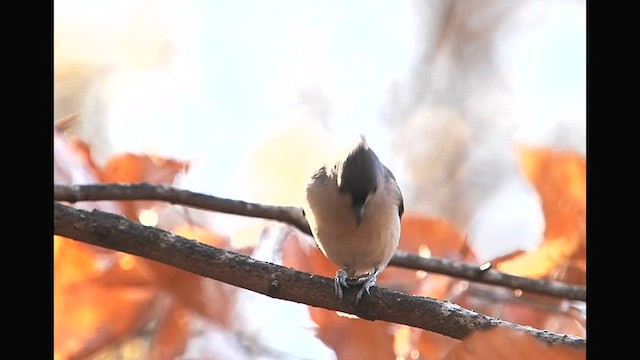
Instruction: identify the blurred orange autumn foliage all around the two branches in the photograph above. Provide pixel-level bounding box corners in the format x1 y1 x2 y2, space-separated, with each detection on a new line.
53 132 586 360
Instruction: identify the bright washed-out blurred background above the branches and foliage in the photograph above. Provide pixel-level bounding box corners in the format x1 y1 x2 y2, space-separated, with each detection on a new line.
54 0 586 358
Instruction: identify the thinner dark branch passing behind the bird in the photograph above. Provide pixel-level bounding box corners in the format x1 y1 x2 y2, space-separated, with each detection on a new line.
54 183 587 301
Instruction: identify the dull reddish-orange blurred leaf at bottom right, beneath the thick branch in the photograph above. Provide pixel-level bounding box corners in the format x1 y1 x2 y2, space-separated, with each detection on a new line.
443 327 587 360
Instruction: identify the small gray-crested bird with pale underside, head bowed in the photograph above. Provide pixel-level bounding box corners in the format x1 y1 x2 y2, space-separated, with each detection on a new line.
304 136 404 306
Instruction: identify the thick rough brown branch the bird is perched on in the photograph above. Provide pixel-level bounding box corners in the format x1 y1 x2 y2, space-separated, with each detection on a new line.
53 202 586 349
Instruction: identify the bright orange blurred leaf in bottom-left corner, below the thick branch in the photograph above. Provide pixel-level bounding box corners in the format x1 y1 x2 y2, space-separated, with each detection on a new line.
53 236 157 359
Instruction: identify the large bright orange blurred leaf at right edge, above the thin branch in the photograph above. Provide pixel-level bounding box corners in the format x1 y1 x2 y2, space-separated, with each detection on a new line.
494 147 586 283
